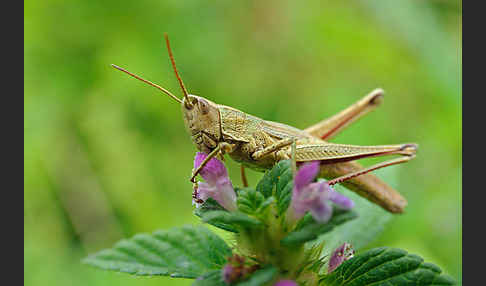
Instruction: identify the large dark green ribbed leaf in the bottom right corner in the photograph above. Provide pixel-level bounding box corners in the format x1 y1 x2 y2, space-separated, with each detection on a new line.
320 247 455 286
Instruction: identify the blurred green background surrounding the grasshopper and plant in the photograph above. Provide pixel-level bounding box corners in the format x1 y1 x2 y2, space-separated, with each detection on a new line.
24 0 462 286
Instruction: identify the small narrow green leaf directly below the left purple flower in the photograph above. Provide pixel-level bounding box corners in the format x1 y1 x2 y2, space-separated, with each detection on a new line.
202 211 263 229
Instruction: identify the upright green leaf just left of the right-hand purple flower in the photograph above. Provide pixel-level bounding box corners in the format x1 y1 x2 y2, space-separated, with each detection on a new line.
256 160 293 215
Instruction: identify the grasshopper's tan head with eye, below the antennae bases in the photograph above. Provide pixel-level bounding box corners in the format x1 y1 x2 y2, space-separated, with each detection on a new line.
181 94 221 153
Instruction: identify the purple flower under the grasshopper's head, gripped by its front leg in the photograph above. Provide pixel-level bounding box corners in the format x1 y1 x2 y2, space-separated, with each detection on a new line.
192 152 237 211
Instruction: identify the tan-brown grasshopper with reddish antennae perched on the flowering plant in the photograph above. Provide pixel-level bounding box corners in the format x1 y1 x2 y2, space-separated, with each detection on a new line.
112 34 418 213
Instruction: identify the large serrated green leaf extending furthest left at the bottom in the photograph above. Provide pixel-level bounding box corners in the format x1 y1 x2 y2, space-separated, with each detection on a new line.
83 226 231 278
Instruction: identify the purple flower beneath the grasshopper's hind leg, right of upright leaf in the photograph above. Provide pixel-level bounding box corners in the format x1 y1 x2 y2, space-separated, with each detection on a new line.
291 161 354 223
